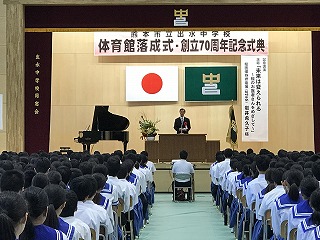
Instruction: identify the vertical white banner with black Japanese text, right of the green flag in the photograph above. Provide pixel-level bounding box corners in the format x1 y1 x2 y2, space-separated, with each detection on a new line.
241 56 268 142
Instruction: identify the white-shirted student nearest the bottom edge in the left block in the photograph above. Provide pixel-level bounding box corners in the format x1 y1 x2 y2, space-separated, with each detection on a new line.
60 190 91 239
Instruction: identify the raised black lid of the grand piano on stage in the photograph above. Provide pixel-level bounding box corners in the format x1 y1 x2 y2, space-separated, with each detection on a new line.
92 106 130 131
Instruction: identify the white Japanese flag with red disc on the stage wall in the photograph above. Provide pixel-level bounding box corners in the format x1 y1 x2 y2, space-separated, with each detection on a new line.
126 66 178 101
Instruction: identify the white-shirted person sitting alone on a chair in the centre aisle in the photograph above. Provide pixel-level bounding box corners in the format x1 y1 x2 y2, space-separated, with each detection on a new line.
172 150 194 201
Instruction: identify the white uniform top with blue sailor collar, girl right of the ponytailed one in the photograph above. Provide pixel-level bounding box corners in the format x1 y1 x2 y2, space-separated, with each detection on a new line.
287 200 313 239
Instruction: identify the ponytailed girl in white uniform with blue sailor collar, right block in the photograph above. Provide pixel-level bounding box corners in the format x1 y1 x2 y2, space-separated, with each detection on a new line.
271 170 303 239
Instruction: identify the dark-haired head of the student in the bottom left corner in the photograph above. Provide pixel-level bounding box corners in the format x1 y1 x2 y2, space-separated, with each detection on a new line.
0 191 27 240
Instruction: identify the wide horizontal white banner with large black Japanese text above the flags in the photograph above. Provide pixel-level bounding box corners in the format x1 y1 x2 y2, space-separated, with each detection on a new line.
94 31 268 56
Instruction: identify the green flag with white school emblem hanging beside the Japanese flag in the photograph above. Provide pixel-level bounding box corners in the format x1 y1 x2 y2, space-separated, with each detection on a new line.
185 66 237 102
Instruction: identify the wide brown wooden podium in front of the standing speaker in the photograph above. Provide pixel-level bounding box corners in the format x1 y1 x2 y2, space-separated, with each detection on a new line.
145 134 220 162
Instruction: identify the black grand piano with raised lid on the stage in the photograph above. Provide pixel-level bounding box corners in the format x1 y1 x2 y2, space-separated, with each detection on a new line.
74 106 130 151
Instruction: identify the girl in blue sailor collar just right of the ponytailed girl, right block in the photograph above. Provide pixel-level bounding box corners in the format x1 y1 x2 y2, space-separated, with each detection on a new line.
287 177 319 239
